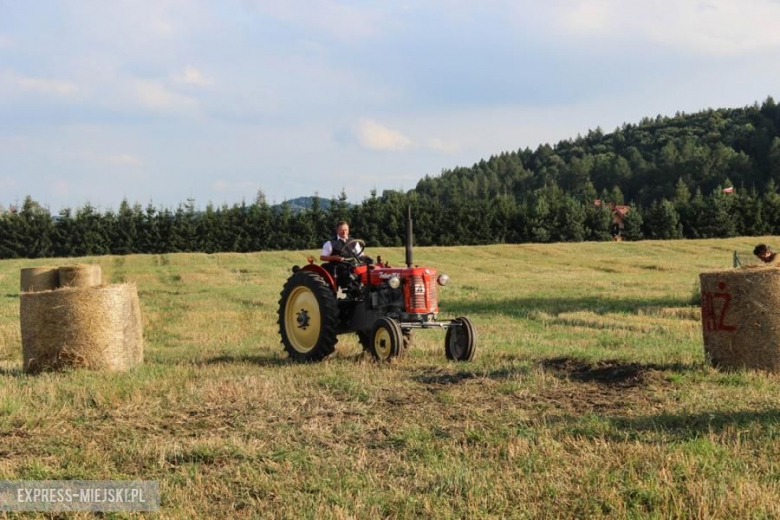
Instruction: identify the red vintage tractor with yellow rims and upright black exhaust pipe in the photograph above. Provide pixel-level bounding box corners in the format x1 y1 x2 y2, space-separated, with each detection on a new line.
279 212 477 361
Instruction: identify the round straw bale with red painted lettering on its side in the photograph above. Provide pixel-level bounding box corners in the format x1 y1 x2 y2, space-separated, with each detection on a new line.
699 267 780 372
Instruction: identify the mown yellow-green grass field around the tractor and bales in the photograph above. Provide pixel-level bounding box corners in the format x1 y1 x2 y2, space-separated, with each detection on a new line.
0 237 780 519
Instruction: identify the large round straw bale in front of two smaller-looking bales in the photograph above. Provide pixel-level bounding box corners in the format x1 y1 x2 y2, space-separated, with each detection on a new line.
20 284 143 372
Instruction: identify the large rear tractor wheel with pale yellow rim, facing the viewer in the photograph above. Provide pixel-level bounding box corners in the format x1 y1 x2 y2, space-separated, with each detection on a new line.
279 271 339 361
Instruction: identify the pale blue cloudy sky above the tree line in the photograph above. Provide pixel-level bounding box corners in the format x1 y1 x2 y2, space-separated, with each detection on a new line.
0 0 780 212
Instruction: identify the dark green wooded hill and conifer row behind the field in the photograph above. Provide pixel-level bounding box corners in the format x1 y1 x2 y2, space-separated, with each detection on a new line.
0 97 780 258
